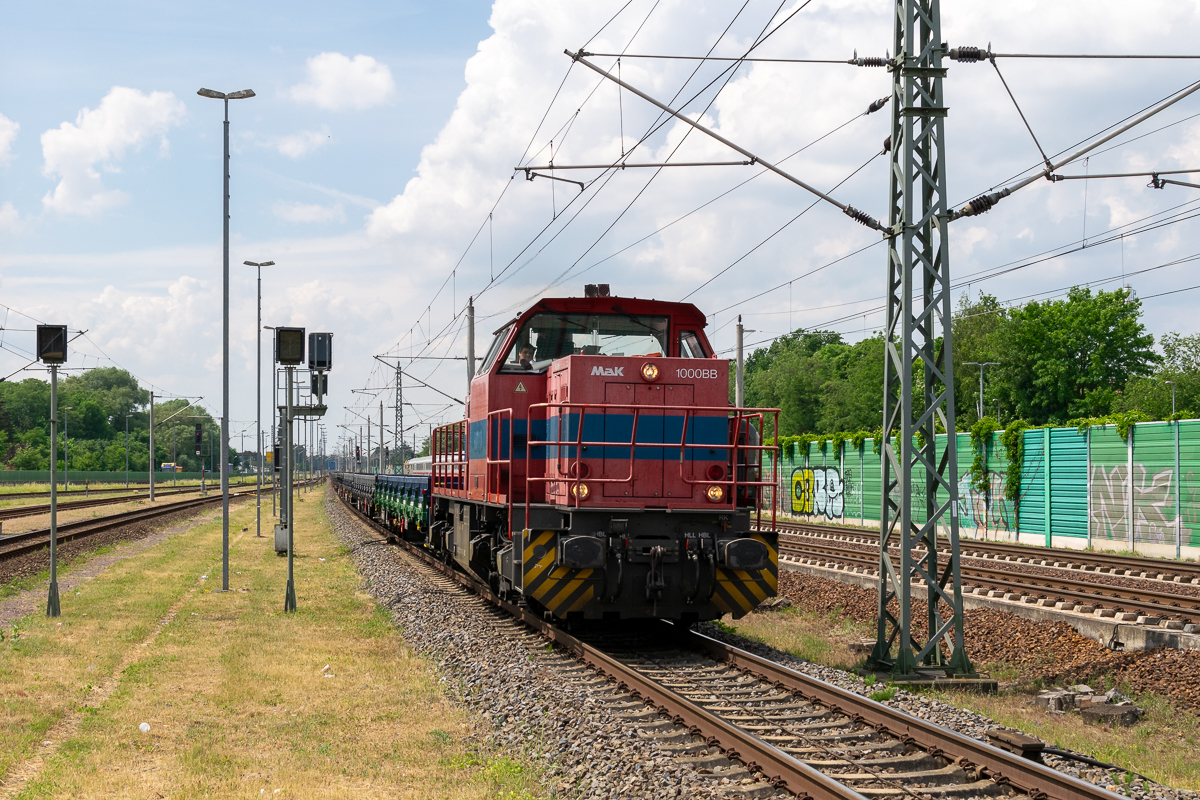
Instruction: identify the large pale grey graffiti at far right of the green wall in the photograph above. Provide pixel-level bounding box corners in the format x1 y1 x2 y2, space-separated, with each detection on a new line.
1088 464 1180 543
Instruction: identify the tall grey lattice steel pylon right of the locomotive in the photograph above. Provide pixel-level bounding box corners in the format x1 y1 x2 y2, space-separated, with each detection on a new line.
869 0 973 676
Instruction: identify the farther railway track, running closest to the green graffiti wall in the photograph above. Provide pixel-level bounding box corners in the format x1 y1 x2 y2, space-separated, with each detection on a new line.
775 519 1200 584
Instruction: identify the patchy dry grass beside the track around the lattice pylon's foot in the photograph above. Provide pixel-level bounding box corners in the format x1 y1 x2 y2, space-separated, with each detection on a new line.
725 608 1200 790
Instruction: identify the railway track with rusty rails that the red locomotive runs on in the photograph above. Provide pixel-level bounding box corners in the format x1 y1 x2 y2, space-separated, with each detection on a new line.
344 491 1112 800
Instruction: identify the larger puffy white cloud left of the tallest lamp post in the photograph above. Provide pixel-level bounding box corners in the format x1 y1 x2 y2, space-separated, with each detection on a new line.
42 86 186 215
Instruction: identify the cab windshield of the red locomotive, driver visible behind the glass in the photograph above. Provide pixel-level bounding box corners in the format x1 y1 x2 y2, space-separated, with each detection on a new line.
500 312 670 372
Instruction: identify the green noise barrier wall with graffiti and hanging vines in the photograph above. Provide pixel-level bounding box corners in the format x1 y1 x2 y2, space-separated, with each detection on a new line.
775 420 1200 558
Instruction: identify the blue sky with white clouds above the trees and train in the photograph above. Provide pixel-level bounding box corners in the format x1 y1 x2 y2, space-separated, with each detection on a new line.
0 0 1200 460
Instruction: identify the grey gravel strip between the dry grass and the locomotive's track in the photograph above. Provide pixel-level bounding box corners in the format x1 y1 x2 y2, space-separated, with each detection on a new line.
326 493 790 799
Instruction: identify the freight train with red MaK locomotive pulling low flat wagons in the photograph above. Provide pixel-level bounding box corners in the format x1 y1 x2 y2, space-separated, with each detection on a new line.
332 284 779 624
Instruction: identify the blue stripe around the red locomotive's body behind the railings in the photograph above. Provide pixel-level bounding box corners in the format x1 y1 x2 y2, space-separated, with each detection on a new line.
467 409 730 461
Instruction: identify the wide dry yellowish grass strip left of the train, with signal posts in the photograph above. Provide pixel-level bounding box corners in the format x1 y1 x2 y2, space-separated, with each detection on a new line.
0 484 538 798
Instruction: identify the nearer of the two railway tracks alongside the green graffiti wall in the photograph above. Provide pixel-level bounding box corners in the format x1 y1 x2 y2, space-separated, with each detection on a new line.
779 534 1200 627
